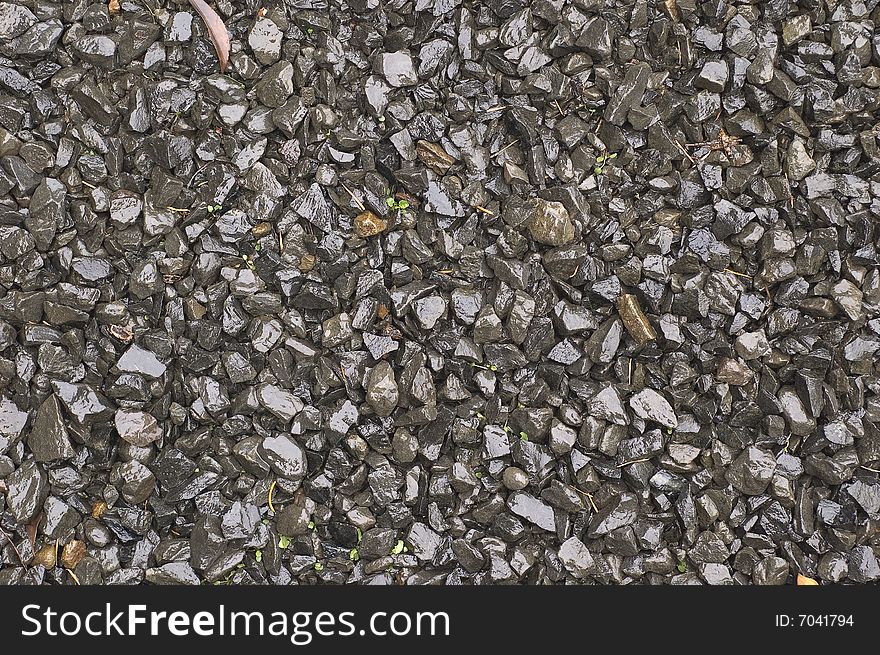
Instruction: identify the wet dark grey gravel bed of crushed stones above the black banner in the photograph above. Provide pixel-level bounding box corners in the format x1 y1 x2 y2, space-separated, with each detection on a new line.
0 0 880 585
